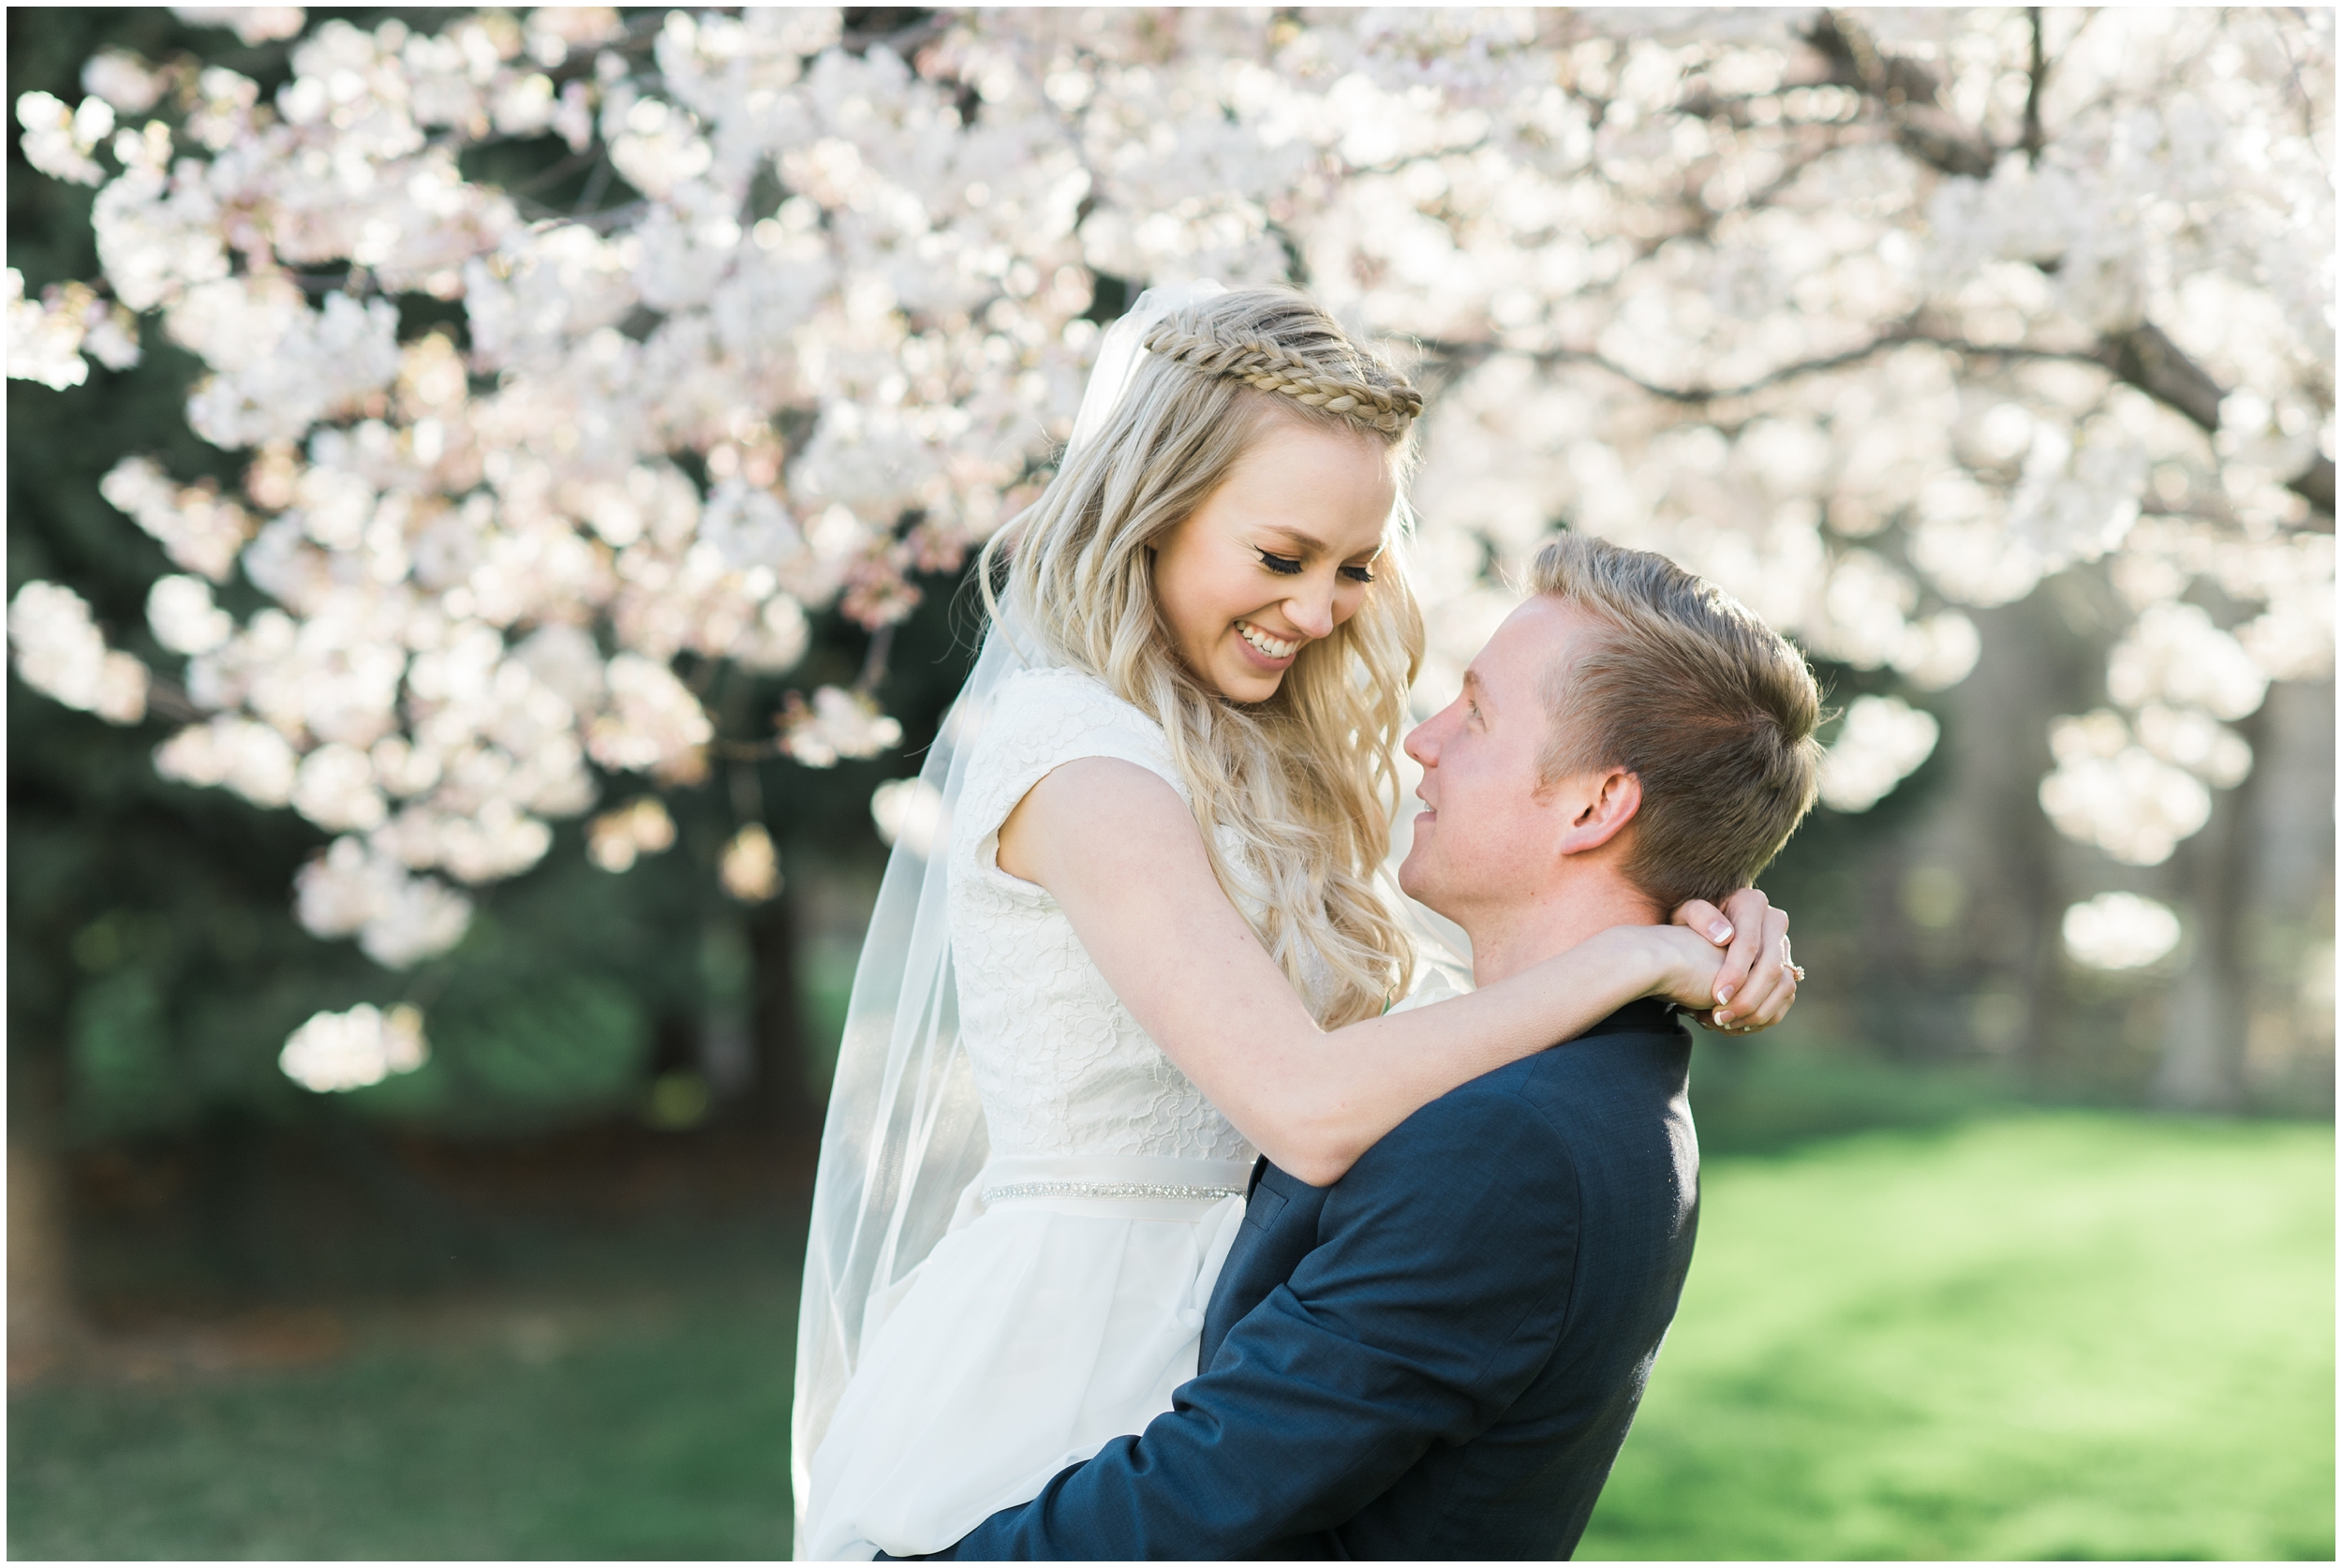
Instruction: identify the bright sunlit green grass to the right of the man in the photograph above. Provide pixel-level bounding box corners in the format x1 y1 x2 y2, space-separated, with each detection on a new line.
1579 1114 2335 1561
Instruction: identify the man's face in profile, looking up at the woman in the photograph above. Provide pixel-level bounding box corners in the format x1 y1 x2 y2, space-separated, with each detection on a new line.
1399 595 1597 925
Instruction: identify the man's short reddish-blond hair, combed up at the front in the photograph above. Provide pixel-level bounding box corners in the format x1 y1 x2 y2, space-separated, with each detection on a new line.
1530 534 1822 912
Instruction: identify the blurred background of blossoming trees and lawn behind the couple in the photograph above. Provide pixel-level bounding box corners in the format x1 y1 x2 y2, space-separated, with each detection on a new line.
7 7 2335 1559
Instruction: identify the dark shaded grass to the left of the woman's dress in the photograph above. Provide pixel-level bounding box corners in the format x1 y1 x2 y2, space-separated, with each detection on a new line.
7 1280 796 1559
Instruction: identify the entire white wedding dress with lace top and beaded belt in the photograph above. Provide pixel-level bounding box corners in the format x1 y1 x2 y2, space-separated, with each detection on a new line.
799 667 1302 1559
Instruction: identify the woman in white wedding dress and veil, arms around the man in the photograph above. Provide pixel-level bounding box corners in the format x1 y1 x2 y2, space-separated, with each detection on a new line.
794 286 1794 1559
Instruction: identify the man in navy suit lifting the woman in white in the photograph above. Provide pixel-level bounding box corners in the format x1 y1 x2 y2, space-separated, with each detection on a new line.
885 536 1820 1559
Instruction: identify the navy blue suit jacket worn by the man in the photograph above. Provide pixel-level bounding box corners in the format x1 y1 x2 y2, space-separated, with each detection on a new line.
904 1001 1698 1561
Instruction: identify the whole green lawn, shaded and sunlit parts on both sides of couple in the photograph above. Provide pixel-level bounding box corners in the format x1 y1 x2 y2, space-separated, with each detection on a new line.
7 1114 2335 1559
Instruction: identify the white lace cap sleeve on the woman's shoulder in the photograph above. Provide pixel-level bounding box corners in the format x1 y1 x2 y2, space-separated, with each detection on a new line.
951 670 1188 887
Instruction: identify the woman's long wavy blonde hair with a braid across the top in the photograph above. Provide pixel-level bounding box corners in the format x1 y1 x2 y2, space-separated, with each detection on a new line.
979 288 1424 1028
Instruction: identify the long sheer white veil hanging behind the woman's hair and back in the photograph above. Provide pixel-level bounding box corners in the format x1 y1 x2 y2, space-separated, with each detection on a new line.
790 281 1223 1547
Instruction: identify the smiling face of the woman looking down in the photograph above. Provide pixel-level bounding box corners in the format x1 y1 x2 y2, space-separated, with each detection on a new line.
1155 414 1399 703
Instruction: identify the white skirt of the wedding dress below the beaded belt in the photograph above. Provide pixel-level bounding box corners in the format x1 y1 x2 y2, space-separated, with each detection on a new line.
799 1156 1251 1561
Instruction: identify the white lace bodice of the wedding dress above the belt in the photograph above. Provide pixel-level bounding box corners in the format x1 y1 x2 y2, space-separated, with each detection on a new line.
951 670 1253 1161
